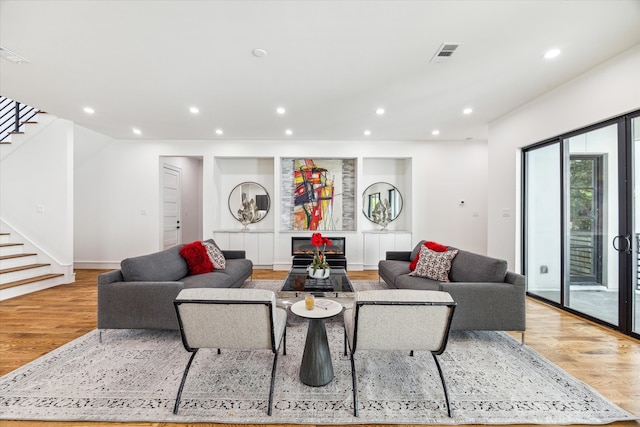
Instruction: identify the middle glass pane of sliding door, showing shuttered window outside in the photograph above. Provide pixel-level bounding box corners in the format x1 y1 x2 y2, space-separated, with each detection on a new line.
563 124 620 326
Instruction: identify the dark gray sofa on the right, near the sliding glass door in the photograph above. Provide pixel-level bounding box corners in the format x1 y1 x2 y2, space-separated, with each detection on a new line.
378 241 526 339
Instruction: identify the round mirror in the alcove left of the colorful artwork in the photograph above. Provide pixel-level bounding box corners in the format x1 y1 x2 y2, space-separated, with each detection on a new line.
229 182 271 230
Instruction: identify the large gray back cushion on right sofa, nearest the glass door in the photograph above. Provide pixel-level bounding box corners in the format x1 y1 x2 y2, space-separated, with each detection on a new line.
449 250 507 282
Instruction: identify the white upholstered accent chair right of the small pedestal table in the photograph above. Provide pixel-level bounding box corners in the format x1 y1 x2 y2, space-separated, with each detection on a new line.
344 289 456 417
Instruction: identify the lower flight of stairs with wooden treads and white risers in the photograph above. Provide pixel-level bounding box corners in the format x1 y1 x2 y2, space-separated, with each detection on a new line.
0 233 64 300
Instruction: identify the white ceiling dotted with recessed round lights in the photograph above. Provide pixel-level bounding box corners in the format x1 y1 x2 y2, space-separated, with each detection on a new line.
0 0 640 140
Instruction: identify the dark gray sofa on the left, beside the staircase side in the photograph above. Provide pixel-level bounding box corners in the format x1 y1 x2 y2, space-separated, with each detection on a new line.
98 240 253 329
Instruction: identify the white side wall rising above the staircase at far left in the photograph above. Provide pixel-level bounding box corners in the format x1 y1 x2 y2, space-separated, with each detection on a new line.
0 119 74 271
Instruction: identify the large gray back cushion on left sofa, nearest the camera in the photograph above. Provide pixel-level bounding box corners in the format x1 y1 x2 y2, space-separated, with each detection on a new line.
120 245 189 282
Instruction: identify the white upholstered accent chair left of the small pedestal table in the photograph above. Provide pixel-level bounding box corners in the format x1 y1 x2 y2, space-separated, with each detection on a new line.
173 288 287 415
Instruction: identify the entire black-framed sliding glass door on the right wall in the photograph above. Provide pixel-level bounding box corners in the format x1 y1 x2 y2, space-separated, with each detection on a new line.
523 112 640 335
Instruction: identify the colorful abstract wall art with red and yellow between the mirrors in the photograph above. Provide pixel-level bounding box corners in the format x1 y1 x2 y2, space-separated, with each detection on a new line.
281 159 356 231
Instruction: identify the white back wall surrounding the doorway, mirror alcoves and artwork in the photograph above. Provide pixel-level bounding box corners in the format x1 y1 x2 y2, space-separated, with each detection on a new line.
75 134 487 267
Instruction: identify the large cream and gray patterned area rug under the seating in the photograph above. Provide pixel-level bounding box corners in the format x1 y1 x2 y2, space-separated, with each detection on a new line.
0 281 636 424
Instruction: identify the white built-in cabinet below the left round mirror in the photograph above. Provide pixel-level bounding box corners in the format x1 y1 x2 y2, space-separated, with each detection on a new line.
213 230 273 267
